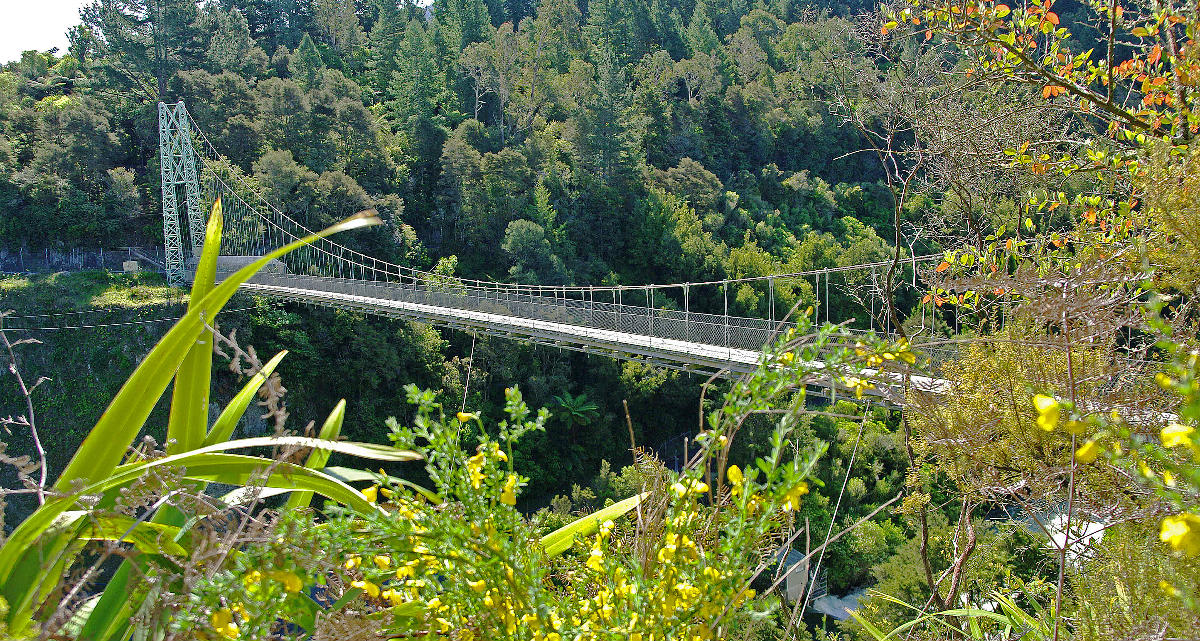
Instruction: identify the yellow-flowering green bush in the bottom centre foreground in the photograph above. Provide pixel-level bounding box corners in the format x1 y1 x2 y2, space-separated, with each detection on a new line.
180 319 911 641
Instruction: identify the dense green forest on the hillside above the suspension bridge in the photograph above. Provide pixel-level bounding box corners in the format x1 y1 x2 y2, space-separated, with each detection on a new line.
0 0 907 292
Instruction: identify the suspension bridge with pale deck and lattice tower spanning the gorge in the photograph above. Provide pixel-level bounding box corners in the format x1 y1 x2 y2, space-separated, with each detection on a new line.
158 102 944 402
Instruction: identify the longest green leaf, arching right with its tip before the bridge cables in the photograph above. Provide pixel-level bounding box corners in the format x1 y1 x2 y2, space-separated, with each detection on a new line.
51 214 380 494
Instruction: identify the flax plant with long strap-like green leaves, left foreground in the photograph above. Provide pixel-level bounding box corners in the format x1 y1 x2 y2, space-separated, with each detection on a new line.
0 200 415 639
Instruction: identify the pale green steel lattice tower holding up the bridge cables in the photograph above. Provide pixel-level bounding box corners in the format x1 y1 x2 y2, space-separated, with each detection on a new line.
158 101 205 286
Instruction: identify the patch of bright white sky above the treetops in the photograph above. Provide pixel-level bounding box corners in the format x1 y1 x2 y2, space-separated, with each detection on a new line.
0 0 90 64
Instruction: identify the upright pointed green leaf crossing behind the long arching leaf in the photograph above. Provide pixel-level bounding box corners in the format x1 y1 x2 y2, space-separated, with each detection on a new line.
167 197 223 454
